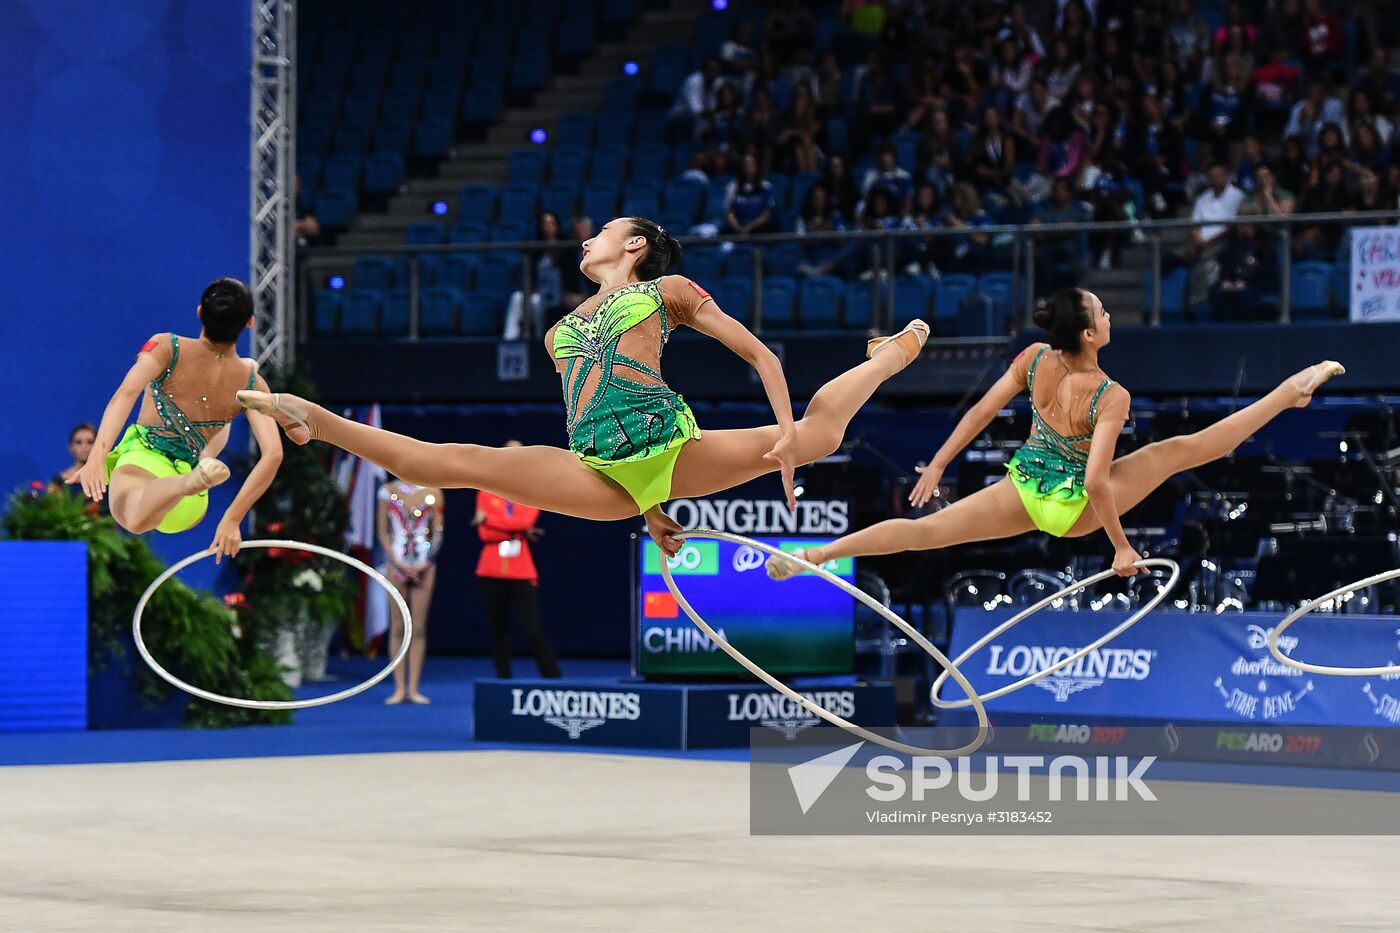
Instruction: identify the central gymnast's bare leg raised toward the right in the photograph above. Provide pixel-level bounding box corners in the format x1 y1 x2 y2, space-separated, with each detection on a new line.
671 329 906 497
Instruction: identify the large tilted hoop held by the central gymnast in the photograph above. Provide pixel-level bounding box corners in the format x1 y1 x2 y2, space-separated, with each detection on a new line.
659 528 987 758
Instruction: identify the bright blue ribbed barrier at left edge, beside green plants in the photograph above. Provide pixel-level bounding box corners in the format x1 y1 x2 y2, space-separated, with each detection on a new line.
0 541 87 733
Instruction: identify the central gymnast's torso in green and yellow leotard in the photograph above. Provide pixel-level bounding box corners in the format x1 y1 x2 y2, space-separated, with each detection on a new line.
546 276 710 513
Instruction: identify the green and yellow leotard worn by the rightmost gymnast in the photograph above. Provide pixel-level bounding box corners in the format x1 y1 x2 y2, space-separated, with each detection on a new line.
1007 346 1113 538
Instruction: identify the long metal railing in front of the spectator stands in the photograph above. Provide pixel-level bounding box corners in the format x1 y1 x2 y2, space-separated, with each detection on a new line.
298 210 1400 340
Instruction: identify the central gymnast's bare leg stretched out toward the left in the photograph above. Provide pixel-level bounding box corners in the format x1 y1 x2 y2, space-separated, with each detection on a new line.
238 392 637 521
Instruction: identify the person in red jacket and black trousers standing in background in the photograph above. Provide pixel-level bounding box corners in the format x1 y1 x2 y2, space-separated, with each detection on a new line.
472 440 559 678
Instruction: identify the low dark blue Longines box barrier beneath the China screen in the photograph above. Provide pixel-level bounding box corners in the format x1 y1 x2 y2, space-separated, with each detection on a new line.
473 679 895 749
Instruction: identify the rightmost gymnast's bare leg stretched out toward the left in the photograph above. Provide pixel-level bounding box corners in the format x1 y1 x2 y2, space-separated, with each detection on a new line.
769 479 1035 580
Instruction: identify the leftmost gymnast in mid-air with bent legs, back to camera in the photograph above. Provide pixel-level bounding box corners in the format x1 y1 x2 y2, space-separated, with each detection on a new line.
67 279 281 560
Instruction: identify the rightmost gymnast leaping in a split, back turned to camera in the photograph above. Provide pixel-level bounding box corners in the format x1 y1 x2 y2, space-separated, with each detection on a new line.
767 289 1345 580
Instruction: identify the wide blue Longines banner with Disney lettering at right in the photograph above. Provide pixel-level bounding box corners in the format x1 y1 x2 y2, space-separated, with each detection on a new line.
941 609 1400 733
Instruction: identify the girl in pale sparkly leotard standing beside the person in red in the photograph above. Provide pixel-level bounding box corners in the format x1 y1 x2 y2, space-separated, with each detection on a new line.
377 476 444 706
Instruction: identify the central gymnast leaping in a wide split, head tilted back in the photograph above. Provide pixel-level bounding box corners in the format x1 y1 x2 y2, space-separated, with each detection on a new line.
238 217 928 555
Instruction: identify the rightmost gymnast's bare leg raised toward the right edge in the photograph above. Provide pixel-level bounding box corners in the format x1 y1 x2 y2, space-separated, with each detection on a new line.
1065 363 1345 538
